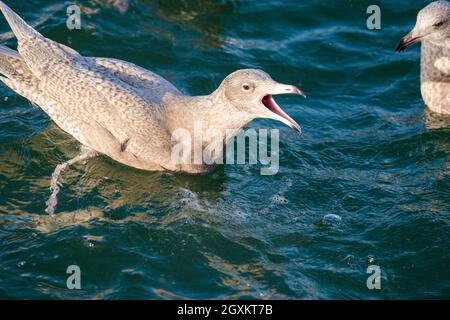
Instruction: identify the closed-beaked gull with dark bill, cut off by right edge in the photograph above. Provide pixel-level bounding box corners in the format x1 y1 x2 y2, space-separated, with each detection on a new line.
396 1 450 114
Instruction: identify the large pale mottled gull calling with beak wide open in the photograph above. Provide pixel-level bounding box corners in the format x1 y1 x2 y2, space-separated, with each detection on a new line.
0 1 304 214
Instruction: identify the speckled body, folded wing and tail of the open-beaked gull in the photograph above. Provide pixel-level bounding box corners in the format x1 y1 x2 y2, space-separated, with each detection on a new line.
0 1 181 170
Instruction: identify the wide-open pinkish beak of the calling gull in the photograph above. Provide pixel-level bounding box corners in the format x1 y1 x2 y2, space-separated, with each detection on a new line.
261 82 306 132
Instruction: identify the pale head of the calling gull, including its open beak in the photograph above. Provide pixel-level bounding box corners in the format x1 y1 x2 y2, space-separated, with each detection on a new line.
219 69 305 132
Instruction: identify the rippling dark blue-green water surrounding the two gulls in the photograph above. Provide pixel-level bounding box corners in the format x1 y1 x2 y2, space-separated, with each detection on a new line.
0 0 450 299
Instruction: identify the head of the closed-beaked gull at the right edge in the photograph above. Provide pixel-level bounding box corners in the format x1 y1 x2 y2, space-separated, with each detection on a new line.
396 1 450 52
